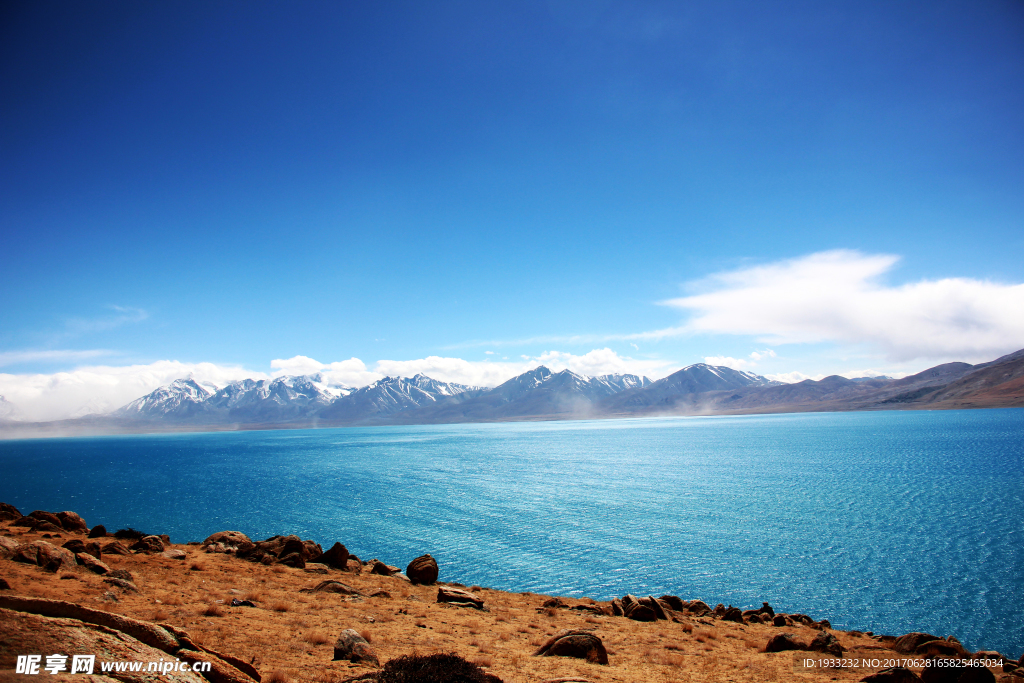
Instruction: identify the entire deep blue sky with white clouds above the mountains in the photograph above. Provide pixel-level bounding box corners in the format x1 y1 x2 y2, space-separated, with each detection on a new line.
0 1 1024 417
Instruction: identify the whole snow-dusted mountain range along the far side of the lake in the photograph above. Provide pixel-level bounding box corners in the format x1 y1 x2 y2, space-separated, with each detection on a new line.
0 349 1024 435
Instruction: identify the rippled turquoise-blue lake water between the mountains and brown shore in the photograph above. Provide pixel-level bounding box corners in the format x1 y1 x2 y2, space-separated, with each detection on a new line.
0 409 1024 657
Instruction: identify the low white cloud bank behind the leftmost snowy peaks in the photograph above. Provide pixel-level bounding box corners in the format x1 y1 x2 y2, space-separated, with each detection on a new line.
0 360 266 421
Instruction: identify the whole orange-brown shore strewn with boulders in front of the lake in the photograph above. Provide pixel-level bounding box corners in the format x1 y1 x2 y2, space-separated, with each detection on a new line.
0 503 1024 683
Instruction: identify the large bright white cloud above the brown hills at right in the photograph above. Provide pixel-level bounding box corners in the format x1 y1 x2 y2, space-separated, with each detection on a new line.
659 251 1024 360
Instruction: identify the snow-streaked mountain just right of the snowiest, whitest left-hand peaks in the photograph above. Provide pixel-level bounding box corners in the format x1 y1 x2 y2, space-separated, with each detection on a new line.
319 375 480 422
